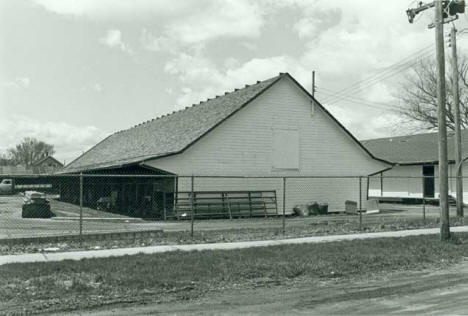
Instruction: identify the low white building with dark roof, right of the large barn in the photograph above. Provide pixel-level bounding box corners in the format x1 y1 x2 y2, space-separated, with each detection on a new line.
361 130 468 200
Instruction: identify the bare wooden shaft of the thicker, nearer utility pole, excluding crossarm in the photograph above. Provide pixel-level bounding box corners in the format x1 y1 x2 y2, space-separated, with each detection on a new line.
434 0 450 240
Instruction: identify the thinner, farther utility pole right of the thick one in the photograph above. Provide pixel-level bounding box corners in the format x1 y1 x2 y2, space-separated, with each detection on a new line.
450 26 464 217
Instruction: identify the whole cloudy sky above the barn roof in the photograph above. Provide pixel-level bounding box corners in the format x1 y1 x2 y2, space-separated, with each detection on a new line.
0 0 468 162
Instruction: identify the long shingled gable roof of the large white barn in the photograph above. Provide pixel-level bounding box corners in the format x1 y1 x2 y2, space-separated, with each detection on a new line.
62 73 388 173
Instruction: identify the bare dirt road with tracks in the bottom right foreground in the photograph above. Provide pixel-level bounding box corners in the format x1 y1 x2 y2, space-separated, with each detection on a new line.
61 260 468 316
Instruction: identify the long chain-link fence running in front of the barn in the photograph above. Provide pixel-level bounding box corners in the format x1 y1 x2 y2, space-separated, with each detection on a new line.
0 174 468 246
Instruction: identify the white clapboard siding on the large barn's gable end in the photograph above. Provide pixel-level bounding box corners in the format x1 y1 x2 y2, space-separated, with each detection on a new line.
146 77 389 213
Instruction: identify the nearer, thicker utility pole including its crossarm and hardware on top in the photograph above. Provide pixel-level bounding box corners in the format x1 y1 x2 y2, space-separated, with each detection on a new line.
406 0 465 240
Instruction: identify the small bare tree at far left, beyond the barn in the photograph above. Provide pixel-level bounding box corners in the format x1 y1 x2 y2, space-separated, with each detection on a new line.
8 137 55 167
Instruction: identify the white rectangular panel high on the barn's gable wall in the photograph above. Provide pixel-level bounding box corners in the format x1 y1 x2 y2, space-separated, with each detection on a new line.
272 129 300 169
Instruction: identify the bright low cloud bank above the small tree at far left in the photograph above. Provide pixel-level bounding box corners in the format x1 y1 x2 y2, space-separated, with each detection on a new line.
0 115 107 162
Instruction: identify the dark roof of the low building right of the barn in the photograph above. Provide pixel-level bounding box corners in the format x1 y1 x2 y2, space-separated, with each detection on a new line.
361 130 468 165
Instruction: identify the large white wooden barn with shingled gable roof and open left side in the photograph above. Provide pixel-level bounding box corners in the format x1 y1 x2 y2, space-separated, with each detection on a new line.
63 73 391 217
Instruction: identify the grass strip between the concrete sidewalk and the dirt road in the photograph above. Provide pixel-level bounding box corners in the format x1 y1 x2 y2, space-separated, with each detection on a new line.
0 234 468 314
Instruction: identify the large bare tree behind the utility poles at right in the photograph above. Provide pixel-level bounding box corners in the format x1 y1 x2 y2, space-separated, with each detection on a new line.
395 56 468 130
